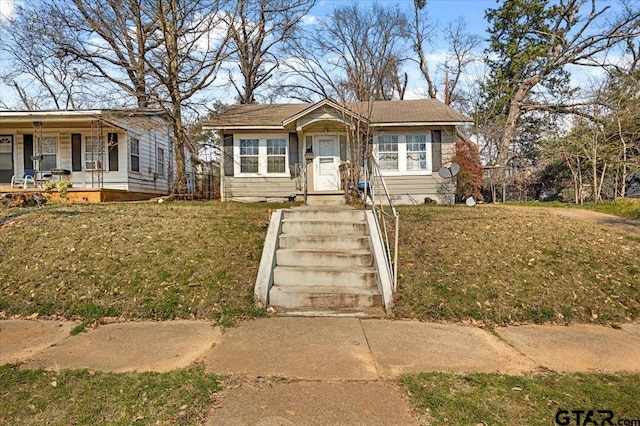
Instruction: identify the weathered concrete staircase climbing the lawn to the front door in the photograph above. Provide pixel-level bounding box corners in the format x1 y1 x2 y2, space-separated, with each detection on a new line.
269 206 384 317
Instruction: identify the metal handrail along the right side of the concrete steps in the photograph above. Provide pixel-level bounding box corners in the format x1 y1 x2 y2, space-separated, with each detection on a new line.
364 157 400 293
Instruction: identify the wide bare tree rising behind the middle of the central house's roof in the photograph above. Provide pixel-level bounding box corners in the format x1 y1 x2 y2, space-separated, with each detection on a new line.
287 3 407 101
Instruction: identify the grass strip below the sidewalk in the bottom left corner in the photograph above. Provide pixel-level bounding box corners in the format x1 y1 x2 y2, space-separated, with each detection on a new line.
0 364 220 426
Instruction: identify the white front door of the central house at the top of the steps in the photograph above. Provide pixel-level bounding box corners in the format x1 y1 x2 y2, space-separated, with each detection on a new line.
313 136 340 191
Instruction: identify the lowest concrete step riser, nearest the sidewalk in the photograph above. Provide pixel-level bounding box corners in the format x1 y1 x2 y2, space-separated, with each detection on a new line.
269 287 382 309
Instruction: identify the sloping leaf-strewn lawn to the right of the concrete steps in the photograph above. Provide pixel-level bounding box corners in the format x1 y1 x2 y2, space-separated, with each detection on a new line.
394 206 640 325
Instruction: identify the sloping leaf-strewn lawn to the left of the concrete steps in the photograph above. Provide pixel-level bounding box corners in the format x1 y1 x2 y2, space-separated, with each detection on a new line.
0 202 292 332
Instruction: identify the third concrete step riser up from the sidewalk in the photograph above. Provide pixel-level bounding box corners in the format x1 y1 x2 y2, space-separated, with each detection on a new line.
276 250 373 268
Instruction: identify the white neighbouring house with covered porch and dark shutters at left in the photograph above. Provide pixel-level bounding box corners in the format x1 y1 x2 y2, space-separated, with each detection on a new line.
0 110 184 201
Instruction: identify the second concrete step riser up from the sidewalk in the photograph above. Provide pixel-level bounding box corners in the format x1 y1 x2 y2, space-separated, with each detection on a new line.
273 267 378 289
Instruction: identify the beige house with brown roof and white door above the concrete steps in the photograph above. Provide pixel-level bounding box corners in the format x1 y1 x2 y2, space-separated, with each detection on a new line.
204 99 470 204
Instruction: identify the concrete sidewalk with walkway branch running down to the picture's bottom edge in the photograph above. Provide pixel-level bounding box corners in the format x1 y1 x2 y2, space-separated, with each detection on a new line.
0 318 640 425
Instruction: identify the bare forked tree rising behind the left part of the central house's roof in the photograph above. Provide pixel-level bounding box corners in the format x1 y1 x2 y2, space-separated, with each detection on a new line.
226 0 315 104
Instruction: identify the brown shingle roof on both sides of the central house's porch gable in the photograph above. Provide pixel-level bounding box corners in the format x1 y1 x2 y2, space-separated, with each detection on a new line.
207 99 471 128
